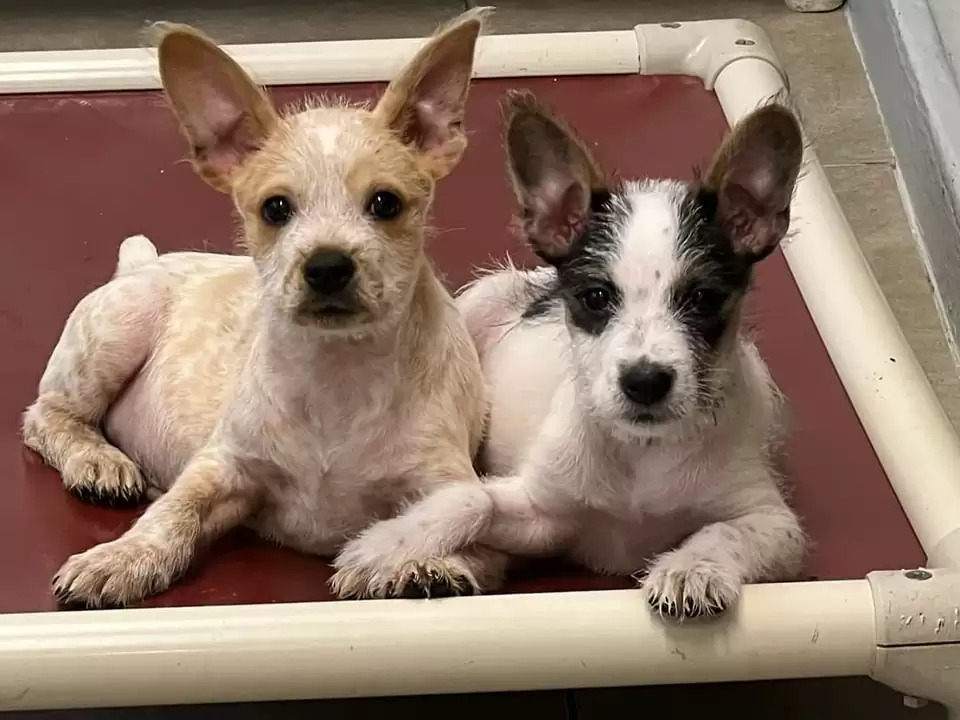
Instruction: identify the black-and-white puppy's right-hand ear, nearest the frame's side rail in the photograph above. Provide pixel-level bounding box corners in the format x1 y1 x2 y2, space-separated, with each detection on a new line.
706 105 803 261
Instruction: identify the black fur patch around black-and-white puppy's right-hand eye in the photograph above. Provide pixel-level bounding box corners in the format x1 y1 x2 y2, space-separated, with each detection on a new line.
670 190 754 376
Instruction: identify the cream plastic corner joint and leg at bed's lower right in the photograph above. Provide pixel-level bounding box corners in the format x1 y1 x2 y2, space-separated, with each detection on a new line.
867 568 960 720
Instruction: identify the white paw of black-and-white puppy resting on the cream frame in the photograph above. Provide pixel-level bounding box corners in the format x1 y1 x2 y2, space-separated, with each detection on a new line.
641 548 743 618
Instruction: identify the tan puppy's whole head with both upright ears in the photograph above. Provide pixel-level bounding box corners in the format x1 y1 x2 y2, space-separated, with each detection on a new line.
154 9 489 328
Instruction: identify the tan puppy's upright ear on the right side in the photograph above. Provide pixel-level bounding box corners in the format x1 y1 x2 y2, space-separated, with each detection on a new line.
374 7 492 179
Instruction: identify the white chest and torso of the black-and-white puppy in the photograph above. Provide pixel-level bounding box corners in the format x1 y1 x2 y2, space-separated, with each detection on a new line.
460 271 776 573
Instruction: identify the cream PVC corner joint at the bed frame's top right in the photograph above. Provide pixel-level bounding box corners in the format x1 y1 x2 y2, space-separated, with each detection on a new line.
634 20 790 90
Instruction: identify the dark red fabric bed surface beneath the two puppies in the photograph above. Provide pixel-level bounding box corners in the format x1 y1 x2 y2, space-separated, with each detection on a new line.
0 76 923 612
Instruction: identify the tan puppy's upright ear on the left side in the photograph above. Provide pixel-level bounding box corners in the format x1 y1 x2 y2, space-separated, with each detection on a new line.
150 23 279 191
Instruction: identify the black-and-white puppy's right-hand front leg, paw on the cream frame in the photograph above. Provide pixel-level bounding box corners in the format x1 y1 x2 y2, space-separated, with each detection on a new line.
643 491 805 617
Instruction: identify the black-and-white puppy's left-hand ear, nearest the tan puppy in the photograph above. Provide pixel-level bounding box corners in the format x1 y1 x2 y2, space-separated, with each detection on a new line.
503 91 605 264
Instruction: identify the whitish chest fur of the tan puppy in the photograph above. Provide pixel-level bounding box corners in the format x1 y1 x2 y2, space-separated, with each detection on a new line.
223 320 432 554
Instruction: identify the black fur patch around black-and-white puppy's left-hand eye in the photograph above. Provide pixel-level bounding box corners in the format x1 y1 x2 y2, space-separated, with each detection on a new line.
553 190 621 335
